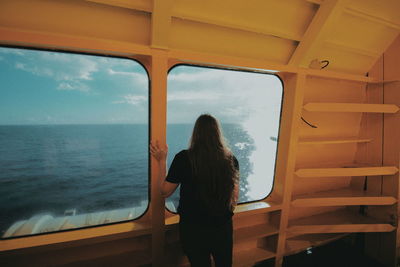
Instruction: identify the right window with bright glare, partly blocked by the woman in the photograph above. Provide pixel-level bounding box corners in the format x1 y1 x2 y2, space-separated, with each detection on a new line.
167 65 283 211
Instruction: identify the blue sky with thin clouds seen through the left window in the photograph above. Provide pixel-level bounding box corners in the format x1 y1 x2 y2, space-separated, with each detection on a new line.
0 47 148 125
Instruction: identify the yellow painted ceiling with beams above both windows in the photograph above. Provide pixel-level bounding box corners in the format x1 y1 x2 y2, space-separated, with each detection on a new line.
0 0 400 74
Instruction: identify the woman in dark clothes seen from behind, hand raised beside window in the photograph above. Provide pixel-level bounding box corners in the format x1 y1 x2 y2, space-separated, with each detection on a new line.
150 114 239 267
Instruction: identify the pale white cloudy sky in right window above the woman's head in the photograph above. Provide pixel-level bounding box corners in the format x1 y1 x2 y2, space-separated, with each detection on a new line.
168 66 282 127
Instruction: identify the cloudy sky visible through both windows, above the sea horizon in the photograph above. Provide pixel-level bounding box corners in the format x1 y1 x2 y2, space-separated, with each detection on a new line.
0 47 282 128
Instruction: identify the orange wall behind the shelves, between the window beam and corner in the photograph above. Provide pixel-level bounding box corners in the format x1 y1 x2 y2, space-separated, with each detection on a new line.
290 77 366 219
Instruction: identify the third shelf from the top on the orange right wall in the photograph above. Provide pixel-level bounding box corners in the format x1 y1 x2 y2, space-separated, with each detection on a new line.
295 166 399 177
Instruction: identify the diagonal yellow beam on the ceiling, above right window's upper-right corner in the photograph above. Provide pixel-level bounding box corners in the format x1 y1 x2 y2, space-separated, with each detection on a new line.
288 0 345 67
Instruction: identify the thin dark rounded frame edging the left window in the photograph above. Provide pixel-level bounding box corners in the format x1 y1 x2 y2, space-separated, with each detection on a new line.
0 44 152 241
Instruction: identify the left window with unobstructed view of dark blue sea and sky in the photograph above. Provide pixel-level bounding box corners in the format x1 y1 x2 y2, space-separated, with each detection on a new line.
0 47 149 238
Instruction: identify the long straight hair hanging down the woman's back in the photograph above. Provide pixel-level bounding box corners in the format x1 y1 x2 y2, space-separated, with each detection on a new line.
189 114 239 215
